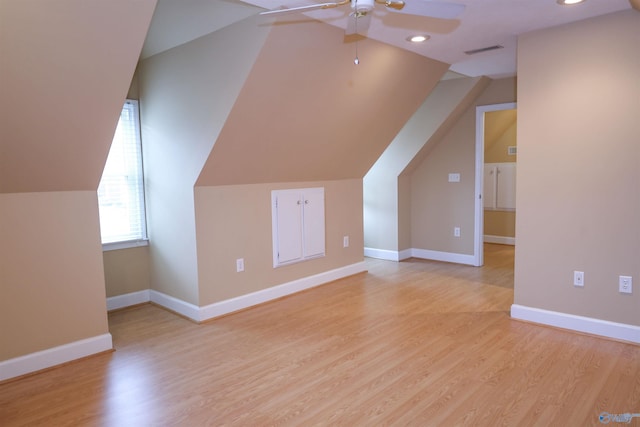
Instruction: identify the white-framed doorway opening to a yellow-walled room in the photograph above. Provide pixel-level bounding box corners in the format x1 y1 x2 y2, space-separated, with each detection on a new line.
474 102 517 266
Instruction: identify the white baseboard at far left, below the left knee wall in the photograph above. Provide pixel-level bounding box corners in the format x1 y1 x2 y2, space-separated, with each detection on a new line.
0 333 113 381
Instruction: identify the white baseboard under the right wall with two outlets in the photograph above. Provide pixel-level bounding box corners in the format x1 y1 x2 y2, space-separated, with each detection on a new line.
511 304 640 344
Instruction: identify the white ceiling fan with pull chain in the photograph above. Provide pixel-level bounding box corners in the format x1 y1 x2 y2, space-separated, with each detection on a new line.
260 0 465 35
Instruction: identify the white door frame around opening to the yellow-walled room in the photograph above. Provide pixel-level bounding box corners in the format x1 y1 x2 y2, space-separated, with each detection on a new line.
473 102 517 267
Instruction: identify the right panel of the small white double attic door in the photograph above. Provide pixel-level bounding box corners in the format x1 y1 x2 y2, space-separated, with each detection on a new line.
303 188 325 258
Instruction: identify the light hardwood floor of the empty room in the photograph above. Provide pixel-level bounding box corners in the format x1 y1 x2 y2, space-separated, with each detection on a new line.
0 245 640 427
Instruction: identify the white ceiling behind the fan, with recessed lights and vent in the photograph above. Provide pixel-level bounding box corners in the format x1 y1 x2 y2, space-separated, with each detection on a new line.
142 0 631 78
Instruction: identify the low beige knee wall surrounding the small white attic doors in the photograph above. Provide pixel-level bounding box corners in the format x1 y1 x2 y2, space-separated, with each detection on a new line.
196 179 363 305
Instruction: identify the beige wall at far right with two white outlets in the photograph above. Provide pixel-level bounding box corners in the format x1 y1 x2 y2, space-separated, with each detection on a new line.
515 10 640 326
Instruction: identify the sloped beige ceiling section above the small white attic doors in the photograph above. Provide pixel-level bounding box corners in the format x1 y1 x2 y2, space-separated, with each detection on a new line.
196 18 448 186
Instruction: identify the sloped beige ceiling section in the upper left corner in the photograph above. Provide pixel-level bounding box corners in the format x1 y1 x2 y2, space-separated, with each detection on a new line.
0 0 156 193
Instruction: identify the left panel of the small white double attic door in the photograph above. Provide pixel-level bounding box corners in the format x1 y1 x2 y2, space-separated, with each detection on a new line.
274 191 303 264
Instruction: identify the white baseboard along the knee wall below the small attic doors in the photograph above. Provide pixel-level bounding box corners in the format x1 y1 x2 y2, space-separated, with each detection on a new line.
200 261 367 321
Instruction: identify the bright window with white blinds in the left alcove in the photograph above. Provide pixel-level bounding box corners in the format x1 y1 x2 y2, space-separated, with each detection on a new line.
98 100 147 250
